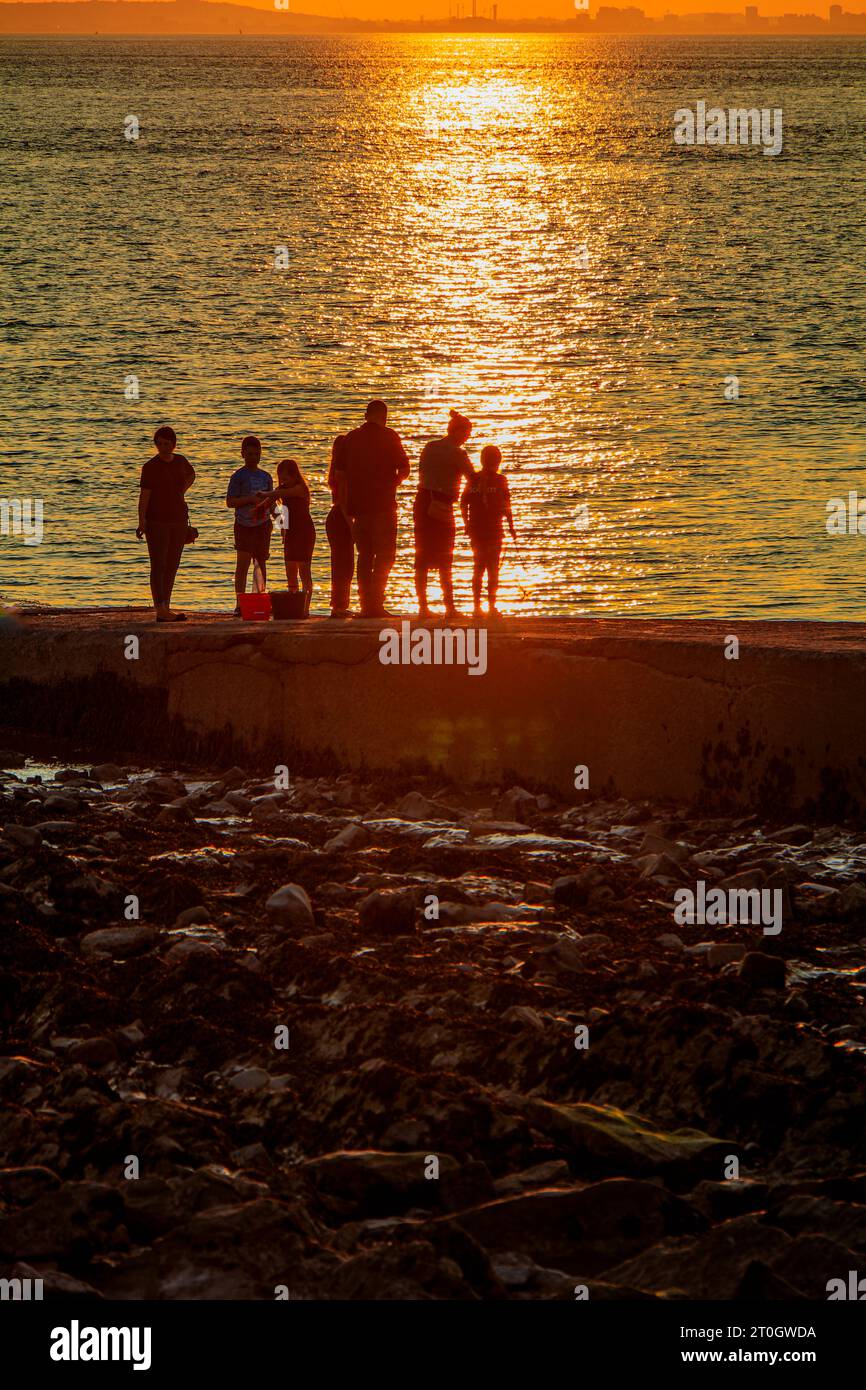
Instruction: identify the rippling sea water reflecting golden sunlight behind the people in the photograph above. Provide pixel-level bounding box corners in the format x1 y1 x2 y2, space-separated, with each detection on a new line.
0 36 866 617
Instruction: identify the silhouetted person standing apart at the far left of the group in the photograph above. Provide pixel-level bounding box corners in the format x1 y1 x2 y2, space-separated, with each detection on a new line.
135 425 196 623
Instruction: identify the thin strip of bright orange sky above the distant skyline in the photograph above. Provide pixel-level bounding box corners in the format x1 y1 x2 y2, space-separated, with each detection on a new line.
0 0 850 19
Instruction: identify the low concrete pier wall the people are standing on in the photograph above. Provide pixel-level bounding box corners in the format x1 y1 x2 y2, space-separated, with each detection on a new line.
0 609 866 819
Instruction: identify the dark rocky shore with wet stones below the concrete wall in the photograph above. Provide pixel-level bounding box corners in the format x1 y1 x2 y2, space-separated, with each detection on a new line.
0 745 866 1300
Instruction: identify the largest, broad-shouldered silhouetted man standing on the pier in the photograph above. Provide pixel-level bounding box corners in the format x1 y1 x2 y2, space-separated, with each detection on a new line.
332 400 409 617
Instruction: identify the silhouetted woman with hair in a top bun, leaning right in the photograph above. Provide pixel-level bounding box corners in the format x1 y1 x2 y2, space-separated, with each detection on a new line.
413 410 474 617
